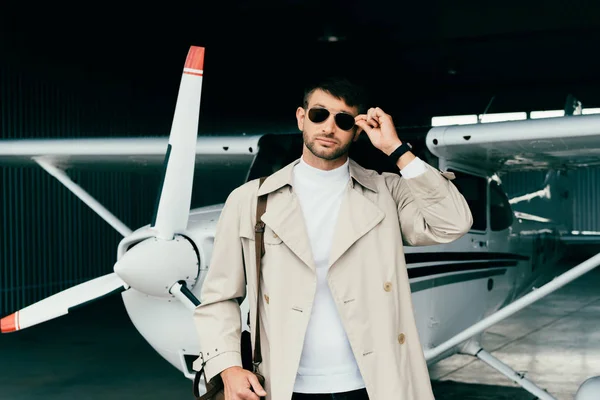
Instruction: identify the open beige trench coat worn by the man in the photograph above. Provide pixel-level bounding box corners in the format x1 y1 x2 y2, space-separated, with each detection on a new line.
194 160 472 400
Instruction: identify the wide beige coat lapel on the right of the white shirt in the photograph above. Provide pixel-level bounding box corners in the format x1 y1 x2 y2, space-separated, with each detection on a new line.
329 184 385 267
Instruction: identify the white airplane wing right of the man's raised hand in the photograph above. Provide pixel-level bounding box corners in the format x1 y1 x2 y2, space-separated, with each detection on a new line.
426 115 600 172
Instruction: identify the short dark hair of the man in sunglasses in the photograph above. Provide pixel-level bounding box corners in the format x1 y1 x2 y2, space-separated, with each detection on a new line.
303 76 367 114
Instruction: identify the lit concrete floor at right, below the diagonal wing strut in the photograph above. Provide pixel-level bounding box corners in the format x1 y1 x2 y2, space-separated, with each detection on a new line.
430 258 600 400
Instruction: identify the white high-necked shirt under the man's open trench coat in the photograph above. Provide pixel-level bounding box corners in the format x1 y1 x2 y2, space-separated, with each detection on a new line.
293 158 426 393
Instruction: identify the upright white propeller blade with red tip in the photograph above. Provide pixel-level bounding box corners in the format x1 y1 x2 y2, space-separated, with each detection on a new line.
151 46 204 240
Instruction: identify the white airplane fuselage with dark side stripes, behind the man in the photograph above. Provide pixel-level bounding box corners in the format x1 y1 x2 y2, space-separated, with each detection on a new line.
119 184 562 378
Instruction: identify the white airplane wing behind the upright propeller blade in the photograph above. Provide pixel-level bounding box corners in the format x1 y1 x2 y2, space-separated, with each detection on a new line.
0 134 268 216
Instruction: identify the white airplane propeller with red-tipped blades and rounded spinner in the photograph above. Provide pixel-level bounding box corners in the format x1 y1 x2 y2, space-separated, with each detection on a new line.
0 46 204 333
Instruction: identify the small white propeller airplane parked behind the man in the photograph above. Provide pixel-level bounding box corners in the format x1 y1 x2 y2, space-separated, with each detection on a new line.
0 46 600 399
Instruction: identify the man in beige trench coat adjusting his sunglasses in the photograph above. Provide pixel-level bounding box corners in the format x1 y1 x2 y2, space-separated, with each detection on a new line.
194 76 472 400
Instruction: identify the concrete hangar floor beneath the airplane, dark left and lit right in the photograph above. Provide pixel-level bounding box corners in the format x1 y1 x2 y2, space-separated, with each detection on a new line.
0 258 600 400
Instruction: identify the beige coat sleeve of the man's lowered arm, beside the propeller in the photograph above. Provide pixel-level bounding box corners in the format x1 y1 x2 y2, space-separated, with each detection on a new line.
193 189 246 381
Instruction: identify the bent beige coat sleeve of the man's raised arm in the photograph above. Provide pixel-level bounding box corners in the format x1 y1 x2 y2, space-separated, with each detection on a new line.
385 164 473 246
